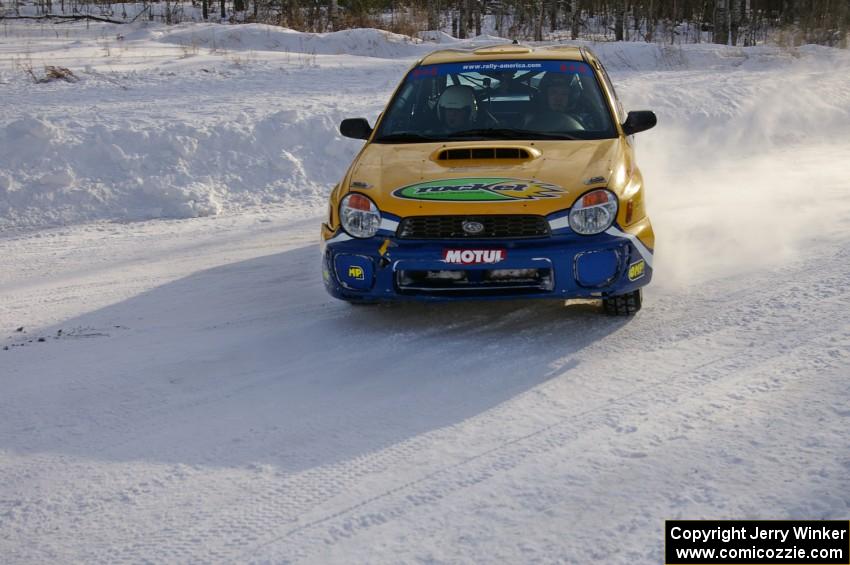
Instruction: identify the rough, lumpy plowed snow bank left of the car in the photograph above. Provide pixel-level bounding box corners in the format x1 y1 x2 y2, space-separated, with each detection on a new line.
0 110 356 227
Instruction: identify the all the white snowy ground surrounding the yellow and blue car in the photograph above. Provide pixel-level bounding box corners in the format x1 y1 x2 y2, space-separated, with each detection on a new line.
0 19 850 563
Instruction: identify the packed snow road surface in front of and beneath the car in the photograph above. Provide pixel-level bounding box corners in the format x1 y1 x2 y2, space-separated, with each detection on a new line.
0 208 850 562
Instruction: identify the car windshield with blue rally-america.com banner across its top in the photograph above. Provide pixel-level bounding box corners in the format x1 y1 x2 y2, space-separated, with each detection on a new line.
374 60 616 143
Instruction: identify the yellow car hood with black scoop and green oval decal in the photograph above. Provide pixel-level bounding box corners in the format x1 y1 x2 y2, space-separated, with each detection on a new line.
348 138 626 217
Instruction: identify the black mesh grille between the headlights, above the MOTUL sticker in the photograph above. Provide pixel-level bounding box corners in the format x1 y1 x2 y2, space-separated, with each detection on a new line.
396 215 549 239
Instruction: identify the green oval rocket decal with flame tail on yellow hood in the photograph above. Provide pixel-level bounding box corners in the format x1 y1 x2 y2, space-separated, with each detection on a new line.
393 177 565 202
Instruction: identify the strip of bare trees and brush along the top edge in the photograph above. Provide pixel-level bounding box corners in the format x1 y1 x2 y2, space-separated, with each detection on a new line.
16 0 850 47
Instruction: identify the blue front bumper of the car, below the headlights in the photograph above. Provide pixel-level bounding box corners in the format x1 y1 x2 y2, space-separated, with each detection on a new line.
322 227 652 301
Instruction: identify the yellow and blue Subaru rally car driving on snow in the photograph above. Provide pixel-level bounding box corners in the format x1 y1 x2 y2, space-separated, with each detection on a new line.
321 44 656 315
